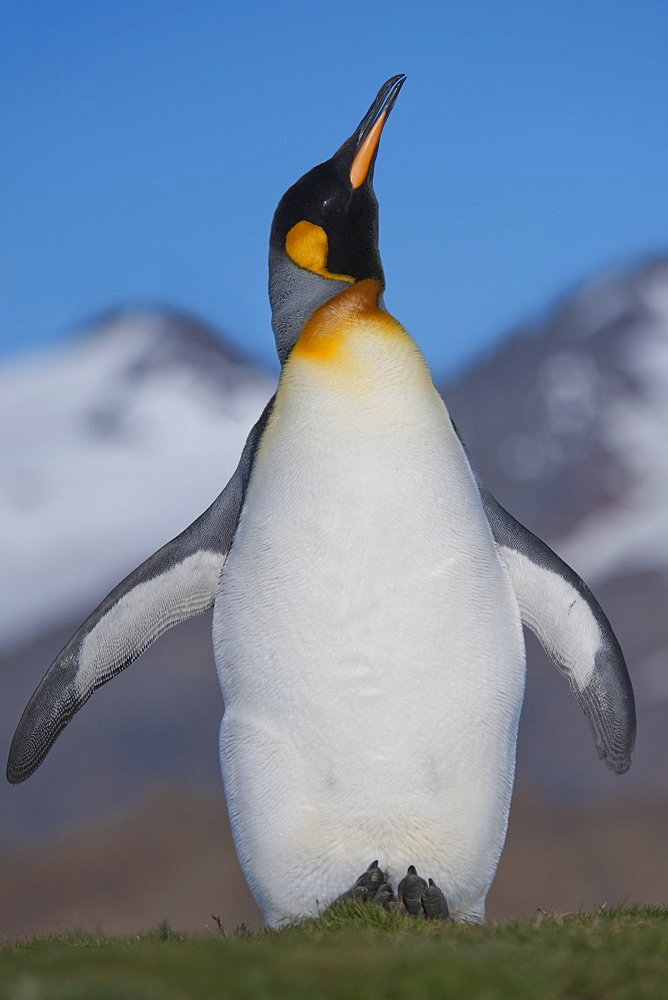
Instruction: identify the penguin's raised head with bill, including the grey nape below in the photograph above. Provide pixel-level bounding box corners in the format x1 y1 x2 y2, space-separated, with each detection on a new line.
269 74 406 363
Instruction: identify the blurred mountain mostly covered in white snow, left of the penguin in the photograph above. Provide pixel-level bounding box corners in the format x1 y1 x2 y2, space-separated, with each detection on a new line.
0 310 273 648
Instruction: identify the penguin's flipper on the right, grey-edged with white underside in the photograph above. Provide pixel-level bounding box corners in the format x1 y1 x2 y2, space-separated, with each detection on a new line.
478 480 636 774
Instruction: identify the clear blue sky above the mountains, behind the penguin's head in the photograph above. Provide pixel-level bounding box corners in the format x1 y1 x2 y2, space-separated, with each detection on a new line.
0 0 668 374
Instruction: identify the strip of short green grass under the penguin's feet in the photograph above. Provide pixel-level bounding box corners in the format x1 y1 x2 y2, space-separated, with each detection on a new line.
0 903 668 1000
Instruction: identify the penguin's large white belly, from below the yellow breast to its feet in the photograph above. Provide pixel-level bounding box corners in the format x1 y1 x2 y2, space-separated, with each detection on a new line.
214 350 524 922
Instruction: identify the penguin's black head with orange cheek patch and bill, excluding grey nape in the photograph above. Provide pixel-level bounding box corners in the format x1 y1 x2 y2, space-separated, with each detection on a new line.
270 74 406 293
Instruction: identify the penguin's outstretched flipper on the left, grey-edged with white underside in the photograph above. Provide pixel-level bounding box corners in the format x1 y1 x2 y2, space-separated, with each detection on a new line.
7 400 273 784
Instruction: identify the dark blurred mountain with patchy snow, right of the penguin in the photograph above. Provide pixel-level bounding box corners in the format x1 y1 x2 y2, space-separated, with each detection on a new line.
444 254 668 579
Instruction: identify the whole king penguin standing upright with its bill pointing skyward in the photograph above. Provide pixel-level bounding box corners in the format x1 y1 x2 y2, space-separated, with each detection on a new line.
7 75 635 925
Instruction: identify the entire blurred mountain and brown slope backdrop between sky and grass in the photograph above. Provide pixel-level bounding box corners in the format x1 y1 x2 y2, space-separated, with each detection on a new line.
0 257 668 936
